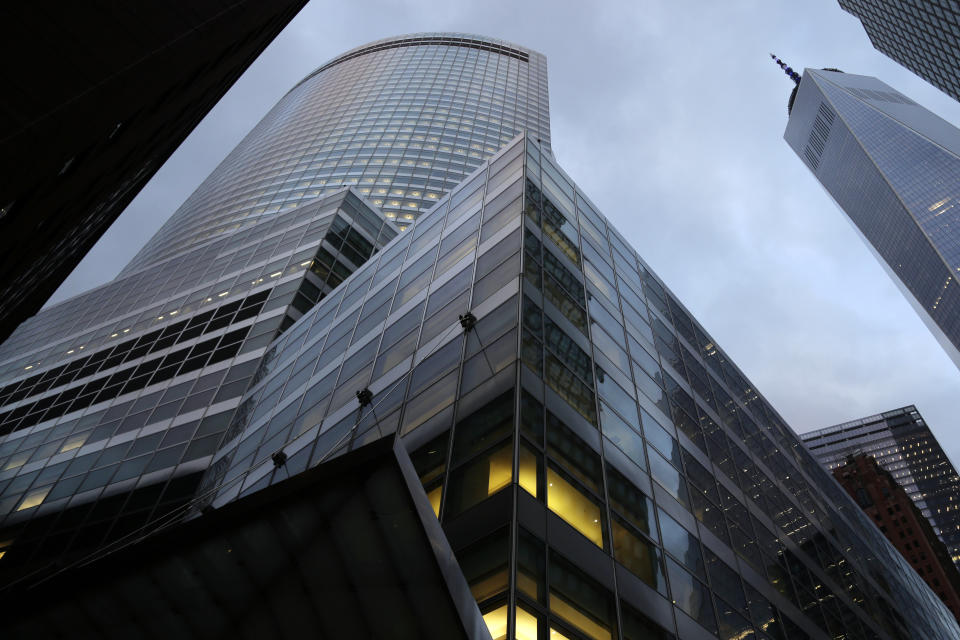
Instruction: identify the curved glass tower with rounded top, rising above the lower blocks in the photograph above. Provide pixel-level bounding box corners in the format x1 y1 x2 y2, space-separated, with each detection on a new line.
124 33 550 273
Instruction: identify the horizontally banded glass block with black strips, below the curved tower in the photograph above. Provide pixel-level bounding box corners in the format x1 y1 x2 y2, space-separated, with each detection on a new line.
0 190 399 571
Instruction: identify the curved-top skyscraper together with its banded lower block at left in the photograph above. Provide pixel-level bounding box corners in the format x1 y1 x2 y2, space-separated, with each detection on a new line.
0 34 549 568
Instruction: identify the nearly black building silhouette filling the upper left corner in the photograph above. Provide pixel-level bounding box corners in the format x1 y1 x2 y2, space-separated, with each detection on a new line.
0 0 305 341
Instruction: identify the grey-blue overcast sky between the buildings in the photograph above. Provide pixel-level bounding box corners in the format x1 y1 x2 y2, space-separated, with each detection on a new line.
45 0 960 462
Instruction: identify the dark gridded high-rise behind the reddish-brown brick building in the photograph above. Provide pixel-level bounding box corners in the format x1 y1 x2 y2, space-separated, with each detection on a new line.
801 405 960 567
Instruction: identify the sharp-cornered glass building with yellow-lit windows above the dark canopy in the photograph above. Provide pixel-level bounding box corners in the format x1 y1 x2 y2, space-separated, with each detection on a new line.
198 138 960 639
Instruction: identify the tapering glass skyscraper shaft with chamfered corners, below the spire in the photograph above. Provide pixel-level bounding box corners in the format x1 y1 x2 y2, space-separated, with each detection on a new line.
783 69 960 366
